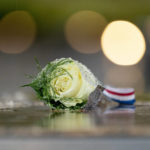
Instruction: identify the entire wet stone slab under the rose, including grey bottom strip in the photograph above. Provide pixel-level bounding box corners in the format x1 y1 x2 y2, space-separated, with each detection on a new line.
0 103 150 150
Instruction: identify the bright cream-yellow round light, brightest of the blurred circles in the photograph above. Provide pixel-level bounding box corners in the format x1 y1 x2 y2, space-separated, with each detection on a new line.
101 21 145 65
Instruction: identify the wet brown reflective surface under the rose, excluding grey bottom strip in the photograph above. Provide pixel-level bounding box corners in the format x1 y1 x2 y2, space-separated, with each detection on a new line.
0 103 150 137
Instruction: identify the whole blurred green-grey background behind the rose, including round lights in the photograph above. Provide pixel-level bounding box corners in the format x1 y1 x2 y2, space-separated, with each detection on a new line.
0 0 150 96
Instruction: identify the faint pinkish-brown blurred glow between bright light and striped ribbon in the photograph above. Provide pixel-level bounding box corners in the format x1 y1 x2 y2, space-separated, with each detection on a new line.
104 66 145 92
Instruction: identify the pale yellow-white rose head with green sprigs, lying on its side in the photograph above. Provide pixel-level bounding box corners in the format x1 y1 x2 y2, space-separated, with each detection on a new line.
24 58 99 108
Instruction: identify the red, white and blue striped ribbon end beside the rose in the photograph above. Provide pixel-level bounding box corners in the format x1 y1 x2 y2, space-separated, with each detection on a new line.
103 86 135 105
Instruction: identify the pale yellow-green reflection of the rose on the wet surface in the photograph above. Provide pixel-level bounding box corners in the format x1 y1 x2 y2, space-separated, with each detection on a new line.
38 111 94 131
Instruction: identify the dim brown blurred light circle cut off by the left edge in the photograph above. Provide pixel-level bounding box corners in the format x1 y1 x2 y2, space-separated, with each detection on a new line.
0 11 36 54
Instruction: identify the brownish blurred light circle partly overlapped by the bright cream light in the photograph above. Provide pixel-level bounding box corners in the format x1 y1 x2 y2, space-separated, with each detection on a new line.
65 11 107 53
